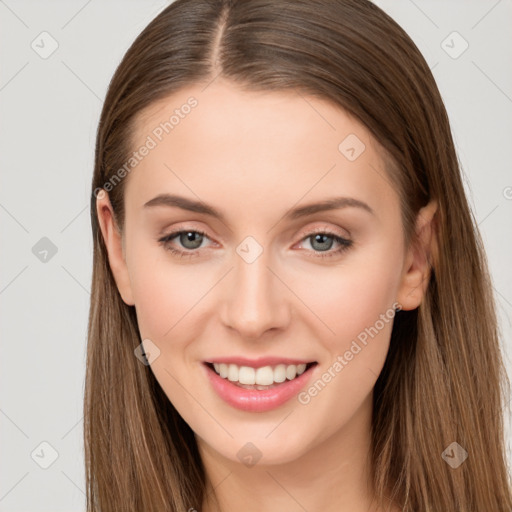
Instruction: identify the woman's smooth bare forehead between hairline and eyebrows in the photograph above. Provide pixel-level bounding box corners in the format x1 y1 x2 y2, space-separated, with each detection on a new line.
126 79 397 222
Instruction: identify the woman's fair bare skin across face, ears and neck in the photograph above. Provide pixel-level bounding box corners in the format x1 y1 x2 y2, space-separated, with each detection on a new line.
97 79 436 512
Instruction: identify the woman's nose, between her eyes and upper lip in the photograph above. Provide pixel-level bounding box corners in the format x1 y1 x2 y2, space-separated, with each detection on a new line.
221 251 290 340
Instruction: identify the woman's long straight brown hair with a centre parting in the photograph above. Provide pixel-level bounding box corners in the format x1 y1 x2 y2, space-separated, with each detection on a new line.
84 0 512 512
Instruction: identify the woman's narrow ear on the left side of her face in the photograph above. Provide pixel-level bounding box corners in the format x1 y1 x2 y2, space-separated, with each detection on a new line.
96 190 135 306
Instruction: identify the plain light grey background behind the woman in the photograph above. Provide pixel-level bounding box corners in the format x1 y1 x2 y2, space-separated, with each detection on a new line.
0 0 512 512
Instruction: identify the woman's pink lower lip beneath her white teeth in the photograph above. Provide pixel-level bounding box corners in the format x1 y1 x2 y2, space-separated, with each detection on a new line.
203 364 317 412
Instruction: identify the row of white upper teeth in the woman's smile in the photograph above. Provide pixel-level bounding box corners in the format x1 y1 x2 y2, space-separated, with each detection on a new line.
213 363 306 386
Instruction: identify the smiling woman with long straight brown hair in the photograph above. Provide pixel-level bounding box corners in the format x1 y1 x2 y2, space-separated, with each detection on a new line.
84 0 512 512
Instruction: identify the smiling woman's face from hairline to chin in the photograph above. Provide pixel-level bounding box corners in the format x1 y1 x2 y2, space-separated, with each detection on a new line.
98 80 430 464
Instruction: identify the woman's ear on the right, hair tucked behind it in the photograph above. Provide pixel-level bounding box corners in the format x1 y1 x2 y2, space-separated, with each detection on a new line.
397 200 438 310
